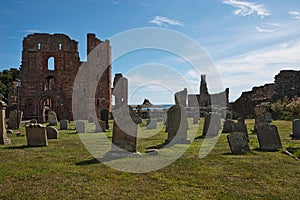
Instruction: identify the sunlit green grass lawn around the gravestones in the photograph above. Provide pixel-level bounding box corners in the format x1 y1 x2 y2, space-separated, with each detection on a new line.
0 119 300 199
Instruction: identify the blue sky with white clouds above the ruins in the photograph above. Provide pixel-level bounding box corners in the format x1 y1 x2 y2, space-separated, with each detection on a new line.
0 0 300 103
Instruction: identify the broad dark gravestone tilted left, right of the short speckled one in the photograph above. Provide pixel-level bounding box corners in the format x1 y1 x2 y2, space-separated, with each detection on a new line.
257 124 282 151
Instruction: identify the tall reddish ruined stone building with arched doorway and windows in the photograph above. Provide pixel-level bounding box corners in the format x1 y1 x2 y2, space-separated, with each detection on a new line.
9 33 111 122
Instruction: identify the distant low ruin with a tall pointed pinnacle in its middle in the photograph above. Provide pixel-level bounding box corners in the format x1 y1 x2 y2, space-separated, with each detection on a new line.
188 74 229 108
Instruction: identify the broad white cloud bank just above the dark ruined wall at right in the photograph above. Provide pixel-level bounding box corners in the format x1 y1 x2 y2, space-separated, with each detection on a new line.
216 40 300 100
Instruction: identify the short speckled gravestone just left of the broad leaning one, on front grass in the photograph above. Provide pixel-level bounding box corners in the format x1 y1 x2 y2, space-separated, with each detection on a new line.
227 132 250 154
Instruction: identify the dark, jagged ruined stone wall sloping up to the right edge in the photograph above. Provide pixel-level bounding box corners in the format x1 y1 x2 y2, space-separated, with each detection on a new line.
230 70 300 118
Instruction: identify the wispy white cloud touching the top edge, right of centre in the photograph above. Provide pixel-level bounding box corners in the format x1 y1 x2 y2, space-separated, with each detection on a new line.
223 0 270 17
